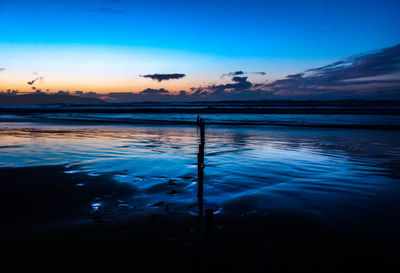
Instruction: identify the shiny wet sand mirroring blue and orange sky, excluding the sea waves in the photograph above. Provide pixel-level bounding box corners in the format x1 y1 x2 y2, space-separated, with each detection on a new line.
0 125 400 217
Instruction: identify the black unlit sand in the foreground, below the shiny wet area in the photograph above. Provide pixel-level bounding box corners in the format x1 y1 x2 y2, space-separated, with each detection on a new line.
0 166 400 272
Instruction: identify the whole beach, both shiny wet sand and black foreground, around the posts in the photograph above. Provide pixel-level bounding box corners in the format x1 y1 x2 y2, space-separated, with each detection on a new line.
0 108 400 272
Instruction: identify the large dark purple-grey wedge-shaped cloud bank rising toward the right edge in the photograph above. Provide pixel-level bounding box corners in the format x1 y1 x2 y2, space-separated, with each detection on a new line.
263 44 400 99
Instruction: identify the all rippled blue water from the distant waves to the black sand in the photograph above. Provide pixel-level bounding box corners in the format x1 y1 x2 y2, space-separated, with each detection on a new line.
0 114 400 232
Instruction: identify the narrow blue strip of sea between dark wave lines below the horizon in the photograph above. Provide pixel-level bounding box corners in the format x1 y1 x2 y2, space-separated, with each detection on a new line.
0 113 400 129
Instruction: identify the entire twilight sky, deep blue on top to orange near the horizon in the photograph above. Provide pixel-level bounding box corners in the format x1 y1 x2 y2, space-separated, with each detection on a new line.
0 0 400 100
